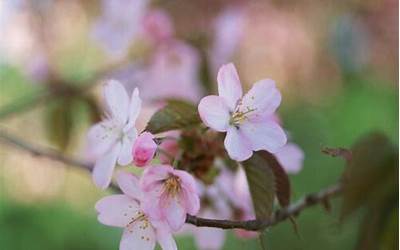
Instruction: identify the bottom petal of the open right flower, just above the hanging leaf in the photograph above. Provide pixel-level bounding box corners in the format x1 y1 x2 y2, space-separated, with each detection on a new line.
224 127 253 161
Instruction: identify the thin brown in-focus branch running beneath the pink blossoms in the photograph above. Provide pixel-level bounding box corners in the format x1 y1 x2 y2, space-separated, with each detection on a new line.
0 130 342 231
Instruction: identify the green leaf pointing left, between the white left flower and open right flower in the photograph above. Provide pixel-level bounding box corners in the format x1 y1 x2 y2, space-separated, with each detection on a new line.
145 100 201 134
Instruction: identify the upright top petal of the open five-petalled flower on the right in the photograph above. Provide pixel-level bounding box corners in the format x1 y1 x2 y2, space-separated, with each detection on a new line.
217 63 243 111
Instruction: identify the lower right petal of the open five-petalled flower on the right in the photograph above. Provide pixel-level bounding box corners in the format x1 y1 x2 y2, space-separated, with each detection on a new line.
240 121 287 153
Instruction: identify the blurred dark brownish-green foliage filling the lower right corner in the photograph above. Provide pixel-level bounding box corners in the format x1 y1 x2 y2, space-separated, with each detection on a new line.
341 133 399 250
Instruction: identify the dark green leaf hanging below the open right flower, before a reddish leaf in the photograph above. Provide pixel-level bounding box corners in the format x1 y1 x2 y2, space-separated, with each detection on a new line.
243 151 276 219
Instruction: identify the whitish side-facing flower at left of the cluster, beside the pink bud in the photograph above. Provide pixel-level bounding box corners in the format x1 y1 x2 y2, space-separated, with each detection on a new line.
88 80 141 189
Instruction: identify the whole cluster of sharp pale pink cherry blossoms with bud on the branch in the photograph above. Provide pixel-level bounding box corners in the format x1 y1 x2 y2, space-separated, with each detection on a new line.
88 61 303 250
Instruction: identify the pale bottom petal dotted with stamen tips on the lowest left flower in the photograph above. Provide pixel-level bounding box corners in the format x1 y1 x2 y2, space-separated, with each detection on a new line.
119 220 156 250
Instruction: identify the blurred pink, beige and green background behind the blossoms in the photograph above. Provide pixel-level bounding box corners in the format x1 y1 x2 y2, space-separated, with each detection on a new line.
0 0 399 250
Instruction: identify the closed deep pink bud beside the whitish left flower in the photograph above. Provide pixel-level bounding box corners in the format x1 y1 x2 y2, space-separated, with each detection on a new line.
132 132 157 167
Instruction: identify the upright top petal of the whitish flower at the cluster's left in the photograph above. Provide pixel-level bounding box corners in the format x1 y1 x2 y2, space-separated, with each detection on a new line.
104 80 129 124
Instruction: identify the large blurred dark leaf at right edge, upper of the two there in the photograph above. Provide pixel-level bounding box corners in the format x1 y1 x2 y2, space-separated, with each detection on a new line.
342 133 398 218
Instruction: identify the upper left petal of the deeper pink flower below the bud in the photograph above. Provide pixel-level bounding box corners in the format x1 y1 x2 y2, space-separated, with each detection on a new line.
140 165 174 192
